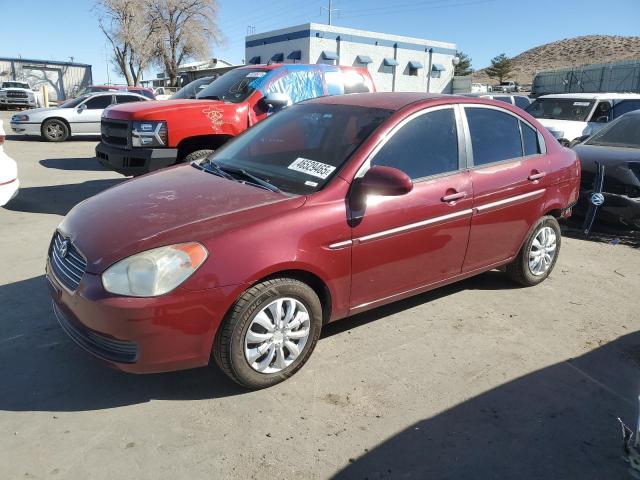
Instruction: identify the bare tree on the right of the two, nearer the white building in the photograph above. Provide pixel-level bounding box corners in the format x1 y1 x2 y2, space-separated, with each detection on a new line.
145 0 221 86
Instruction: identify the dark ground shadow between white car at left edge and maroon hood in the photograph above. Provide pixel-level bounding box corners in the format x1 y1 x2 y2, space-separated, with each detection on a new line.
4 178 126 215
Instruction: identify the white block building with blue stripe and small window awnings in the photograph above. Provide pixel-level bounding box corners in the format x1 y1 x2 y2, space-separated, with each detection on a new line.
245 23 456 93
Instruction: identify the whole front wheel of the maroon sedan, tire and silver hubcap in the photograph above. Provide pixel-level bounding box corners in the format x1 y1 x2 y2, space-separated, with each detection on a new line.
213 278 322 389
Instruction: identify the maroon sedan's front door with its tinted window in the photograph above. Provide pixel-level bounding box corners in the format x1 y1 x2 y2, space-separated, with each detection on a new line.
351 106 473 311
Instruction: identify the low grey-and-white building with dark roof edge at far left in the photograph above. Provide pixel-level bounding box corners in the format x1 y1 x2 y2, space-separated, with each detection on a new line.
0 57 93 101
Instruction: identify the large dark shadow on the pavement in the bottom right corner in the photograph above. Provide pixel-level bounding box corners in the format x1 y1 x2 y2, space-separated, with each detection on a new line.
334 332 640 480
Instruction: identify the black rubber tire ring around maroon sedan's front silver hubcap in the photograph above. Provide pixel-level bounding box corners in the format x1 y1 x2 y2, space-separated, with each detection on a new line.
229 281 322 388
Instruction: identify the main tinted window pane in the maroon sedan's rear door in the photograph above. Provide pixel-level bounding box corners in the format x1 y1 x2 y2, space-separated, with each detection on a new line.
465 108 522 165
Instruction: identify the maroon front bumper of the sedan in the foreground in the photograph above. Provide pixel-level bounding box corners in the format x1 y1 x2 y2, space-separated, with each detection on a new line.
46 261 237 373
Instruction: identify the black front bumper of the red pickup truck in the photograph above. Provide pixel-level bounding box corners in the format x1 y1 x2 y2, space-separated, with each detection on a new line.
96 142 178 176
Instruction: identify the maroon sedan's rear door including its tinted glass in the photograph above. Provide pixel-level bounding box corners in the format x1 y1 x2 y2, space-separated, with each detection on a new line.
463 104 549 272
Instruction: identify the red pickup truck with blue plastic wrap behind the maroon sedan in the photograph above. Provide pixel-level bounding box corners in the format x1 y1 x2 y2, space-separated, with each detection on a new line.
96 64 375 176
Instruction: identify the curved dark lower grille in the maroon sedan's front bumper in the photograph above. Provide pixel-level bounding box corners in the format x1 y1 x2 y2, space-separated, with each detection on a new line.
53 303 138 363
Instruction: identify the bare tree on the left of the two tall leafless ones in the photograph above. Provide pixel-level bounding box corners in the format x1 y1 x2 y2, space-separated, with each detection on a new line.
95 0 155 85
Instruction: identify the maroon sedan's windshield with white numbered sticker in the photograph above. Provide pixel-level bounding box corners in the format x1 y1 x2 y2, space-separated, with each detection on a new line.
201 104 392 195
